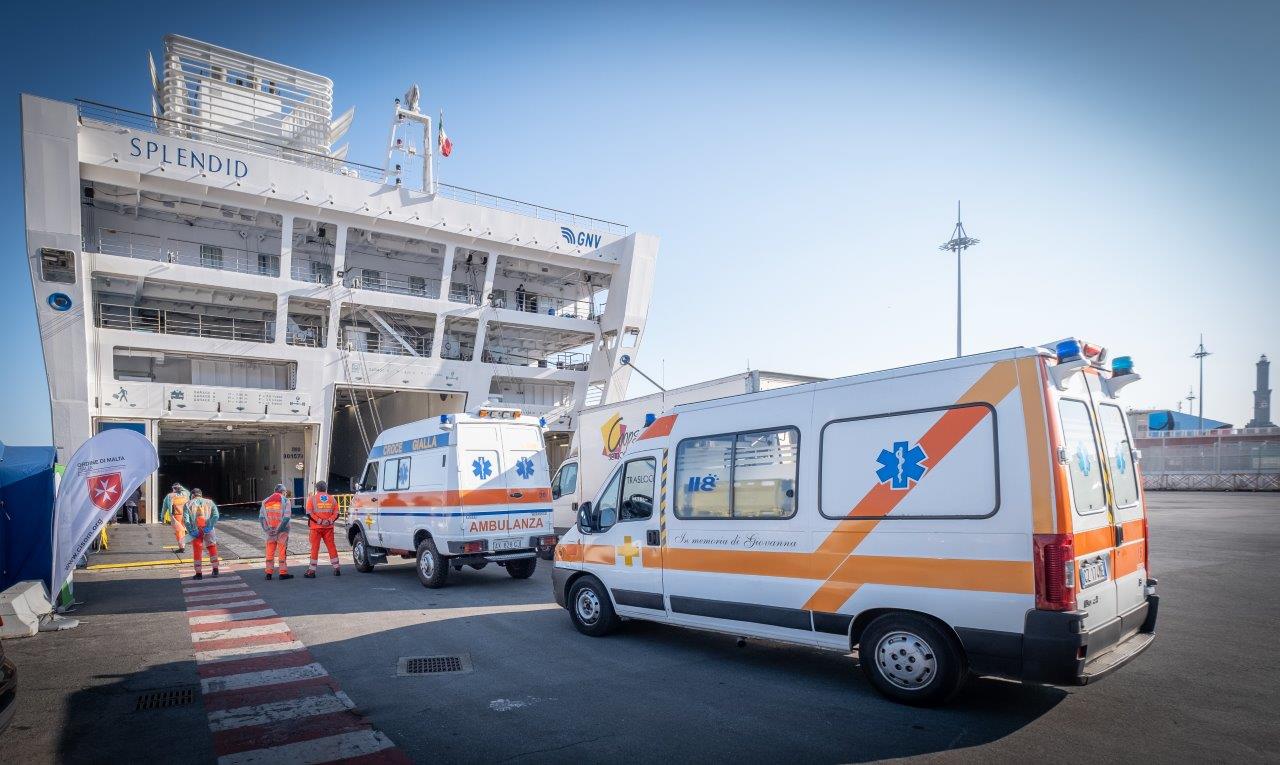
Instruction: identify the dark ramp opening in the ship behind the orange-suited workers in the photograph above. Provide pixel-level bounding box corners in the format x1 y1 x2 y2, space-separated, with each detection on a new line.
157 421 311 510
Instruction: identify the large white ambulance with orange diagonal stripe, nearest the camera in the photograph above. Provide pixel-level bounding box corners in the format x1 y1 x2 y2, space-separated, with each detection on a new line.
552 339 1158 705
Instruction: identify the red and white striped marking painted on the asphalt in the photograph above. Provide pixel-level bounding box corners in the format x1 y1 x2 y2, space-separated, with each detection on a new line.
182 573 410 765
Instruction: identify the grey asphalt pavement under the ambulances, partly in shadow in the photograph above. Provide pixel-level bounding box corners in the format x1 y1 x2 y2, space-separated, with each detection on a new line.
0 493 1280 762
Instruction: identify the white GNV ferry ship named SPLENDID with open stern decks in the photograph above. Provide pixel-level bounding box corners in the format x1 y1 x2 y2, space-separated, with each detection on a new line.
22 36 658 522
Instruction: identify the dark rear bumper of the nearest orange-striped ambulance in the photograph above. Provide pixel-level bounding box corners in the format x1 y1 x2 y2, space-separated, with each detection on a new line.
957 595 1160 686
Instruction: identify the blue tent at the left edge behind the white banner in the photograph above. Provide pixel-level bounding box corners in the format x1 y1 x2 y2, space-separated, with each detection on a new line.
0 443 56 591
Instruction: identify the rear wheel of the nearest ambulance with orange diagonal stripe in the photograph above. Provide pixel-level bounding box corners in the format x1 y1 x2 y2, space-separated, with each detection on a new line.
858 614 969 706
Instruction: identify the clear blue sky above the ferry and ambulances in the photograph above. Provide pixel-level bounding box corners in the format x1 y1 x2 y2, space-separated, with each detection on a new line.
0 1 1280 444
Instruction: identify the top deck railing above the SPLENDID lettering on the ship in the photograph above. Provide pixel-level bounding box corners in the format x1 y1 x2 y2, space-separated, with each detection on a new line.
76 99 631 239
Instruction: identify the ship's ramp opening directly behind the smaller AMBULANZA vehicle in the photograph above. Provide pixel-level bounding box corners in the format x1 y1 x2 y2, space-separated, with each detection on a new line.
329 386 467 493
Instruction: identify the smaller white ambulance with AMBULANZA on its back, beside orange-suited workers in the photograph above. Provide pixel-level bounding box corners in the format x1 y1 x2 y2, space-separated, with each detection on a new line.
347 407 556 587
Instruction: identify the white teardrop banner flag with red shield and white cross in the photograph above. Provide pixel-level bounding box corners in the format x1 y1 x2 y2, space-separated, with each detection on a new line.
49 427 160 599
